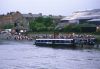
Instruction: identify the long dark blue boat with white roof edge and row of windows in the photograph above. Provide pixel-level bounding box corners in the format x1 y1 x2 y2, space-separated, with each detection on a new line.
35 39 75 47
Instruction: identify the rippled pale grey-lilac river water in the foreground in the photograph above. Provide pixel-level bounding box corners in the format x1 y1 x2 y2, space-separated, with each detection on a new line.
0 41 100 69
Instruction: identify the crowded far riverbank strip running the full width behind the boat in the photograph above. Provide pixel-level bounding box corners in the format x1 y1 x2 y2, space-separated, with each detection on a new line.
0 32 100 44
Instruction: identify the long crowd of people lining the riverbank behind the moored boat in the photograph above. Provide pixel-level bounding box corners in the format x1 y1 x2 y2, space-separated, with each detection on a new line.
0 32 95 41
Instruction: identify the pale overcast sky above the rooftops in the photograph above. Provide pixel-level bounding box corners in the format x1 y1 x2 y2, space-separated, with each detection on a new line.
0 0 100 16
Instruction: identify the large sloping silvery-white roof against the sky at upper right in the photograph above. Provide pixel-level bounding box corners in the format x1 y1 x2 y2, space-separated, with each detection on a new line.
61 9 100 20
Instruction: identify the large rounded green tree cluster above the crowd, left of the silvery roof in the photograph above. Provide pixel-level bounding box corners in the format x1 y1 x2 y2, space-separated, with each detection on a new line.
29 17 55 32
